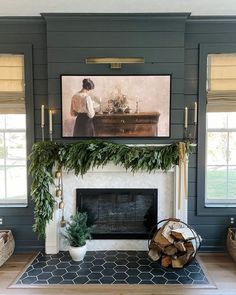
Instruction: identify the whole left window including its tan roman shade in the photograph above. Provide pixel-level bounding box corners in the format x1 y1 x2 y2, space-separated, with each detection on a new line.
0 54 27 205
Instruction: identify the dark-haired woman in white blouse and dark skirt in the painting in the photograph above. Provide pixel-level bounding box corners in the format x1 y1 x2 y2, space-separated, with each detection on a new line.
70 79 95 137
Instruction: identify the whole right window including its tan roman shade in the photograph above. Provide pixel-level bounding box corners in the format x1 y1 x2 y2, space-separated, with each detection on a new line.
205 53 236 207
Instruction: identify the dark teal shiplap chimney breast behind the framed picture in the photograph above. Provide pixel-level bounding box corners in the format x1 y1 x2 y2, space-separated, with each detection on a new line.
42 14 187 143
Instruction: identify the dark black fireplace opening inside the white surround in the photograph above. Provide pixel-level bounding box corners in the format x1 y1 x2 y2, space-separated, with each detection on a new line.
76 189 157 239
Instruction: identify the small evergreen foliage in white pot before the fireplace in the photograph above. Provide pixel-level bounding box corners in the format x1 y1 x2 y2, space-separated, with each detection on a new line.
63 212 91 247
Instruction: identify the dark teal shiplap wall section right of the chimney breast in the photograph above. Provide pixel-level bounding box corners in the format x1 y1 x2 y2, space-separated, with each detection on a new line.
184 17 236 251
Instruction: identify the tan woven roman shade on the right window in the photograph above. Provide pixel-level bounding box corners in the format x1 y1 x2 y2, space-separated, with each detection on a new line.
207 53 236 112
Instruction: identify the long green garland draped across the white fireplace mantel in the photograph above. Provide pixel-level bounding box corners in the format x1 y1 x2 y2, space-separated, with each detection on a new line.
29 140 191 238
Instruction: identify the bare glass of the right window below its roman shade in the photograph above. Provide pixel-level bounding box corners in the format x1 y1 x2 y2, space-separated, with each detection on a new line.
206 112 236 205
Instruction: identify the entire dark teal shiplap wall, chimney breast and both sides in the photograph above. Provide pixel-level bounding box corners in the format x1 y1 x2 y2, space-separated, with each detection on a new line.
0 14 236 250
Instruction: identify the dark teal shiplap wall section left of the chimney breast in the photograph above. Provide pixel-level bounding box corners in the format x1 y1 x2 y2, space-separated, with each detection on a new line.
0 18 47 251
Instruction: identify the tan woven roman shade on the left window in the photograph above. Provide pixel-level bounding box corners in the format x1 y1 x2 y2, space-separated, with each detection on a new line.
0 54 25 114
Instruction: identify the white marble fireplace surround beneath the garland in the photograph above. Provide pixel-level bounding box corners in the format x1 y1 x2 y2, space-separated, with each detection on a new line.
45 164 187 254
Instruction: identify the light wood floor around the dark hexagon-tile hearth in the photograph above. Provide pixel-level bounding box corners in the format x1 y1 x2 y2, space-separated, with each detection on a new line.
0 253 236 295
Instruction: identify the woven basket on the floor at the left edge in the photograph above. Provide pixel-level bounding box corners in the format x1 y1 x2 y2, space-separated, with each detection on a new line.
0 230 15 266
